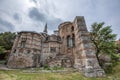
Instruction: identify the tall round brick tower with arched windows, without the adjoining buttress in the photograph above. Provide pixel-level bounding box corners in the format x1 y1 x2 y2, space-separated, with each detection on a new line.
59 22 76 65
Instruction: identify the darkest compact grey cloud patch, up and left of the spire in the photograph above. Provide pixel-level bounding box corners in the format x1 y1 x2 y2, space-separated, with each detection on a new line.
29 8 46 22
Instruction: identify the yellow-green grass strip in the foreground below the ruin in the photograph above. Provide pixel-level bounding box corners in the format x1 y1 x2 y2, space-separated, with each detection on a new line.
0 63 120 80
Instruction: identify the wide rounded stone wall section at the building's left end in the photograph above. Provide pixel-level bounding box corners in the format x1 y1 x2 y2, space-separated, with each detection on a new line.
7 31 43 68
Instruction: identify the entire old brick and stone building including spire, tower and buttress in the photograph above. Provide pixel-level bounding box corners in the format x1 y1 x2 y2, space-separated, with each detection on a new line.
7 16 105 77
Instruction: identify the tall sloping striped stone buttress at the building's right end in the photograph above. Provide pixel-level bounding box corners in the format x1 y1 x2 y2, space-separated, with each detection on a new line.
73 16 105 77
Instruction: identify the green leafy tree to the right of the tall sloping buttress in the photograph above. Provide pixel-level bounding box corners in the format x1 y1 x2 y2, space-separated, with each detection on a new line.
90 22 117 72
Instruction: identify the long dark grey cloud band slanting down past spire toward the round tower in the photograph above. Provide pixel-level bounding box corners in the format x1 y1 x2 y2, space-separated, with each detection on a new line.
29 8 62 30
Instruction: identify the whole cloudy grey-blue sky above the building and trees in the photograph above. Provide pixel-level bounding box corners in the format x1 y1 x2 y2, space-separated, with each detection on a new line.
0 0 120 38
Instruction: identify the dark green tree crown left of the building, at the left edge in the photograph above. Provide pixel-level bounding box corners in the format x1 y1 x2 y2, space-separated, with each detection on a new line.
0 32 16 50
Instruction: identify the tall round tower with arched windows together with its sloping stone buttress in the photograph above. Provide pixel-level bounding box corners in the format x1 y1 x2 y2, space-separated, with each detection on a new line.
59 16 105 77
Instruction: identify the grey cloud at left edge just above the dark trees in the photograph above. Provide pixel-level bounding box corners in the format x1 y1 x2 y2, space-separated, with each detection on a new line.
0 18 14 32
